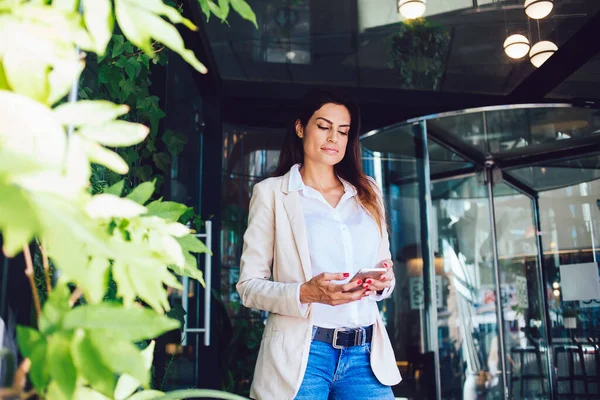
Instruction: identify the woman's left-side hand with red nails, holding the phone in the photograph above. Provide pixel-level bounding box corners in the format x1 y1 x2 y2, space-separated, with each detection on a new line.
300 272 372 306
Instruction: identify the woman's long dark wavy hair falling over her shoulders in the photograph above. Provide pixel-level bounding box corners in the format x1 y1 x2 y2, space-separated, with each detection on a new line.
273 89 385 231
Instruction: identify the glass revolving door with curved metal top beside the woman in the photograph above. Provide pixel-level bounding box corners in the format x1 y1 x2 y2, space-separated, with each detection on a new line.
361 104 600 399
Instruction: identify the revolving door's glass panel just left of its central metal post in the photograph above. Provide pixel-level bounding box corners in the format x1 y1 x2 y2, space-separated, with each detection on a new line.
432 174 503 399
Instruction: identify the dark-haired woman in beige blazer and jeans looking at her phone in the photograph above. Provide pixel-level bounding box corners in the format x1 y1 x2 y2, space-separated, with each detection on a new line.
237 91 401 400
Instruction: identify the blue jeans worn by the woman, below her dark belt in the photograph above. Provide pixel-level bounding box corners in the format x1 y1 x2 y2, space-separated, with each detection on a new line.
296 330 394 400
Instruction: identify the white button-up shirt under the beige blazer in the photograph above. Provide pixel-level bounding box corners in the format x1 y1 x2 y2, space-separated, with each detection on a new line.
288 164 387 328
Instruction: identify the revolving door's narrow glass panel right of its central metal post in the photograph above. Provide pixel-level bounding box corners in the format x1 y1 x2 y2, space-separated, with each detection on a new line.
493 183 551 399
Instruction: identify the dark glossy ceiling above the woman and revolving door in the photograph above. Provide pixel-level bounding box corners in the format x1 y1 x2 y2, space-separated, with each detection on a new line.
182 0 600 131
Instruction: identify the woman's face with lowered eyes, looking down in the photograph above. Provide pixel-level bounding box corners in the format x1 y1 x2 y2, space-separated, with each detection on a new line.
296 103 351 166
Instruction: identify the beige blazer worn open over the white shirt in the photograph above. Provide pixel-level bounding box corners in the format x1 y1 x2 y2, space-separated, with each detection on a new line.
237 172 402 400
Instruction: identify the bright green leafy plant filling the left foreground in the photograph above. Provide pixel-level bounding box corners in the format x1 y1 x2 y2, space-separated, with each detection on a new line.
0 0 256 400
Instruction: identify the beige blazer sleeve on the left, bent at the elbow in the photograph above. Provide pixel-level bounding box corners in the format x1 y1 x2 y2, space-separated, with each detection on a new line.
236 183 308 318
